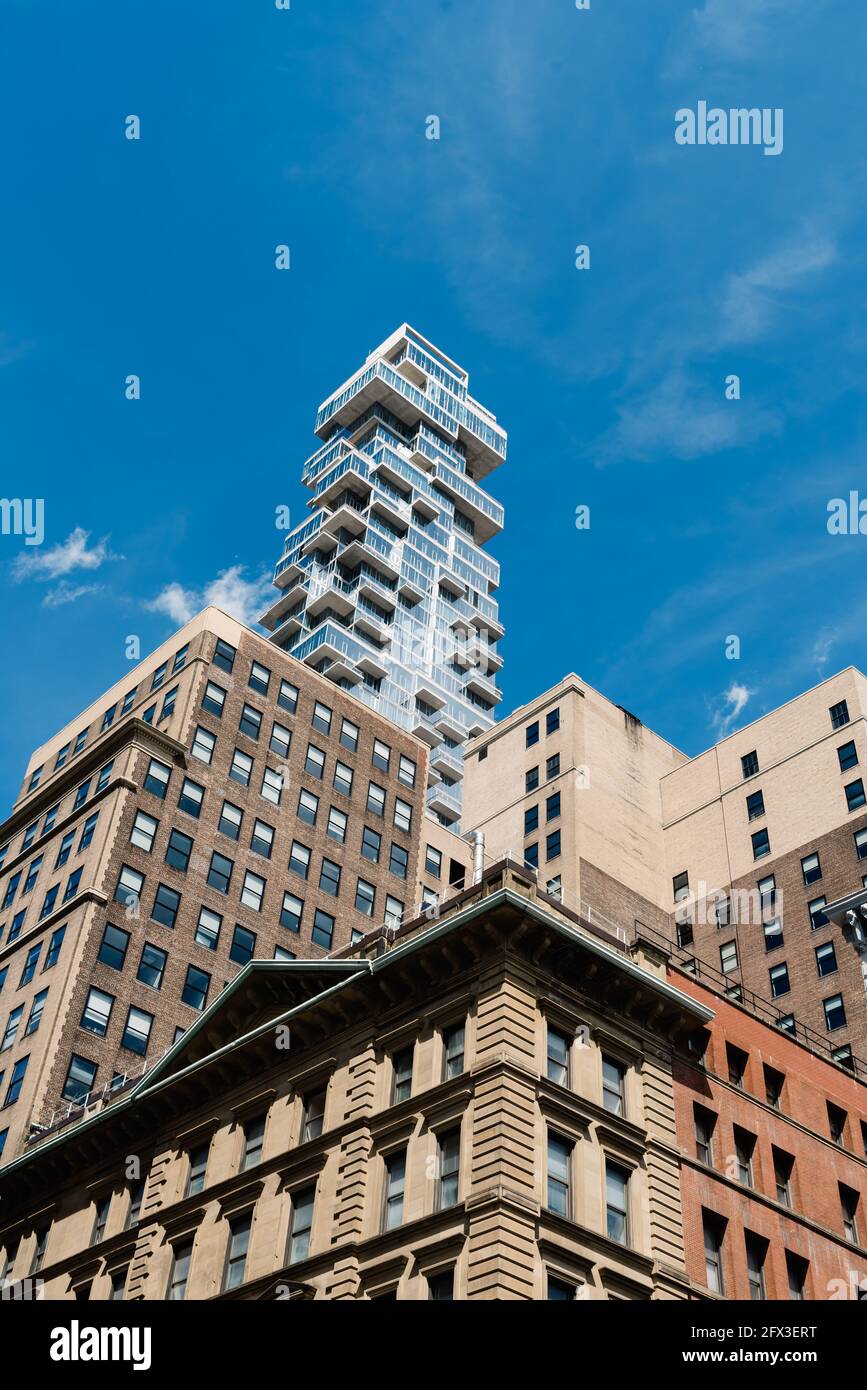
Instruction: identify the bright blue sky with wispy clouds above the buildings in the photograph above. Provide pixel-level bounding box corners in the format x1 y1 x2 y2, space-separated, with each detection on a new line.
0 0 867 805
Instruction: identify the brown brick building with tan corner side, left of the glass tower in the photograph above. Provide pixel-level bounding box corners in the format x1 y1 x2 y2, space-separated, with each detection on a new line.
0 607 470 1161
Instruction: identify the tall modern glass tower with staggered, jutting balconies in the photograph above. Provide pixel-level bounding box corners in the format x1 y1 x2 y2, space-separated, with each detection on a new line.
261 324 506 826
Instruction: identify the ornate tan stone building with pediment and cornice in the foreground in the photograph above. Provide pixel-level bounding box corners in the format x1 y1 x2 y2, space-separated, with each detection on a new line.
0 863 711 1300
